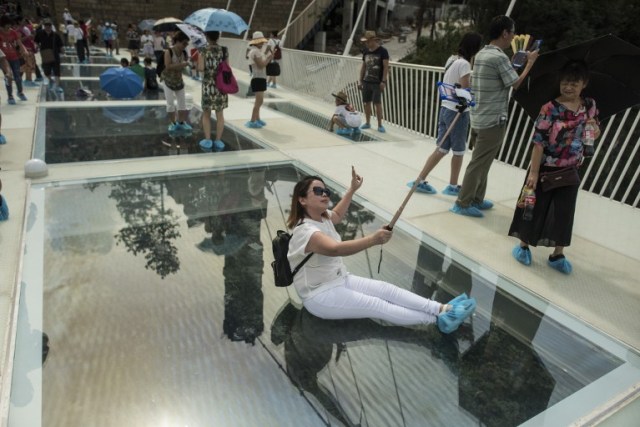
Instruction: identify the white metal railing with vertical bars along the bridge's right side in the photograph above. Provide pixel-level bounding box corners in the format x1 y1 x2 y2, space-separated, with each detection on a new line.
222 39 640 208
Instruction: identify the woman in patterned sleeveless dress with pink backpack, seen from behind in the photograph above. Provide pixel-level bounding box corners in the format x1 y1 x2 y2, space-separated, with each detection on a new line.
198 31 229 151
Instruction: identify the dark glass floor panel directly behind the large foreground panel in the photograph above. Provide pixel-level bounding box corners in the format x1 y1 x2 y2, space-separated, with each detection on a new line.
34 105 264 164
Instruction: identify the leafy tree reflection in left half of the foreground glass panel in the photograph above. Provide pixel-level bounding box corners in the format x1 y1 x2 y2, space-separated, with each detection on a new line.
109 180 180 279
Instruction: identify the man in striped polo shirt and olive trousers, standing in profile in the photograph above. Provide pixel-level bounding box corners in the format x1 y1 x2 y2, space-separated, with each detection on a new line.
451 15 538 217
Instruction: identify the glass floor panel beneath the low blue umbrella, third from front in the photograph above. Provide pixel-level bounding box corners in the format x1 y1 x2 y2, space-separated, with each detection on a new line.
40 78 165 102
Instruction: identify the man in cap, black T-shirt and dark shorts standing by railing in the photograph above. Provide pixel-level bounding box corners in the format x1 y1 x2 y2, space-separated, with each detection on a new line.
358 31 389 132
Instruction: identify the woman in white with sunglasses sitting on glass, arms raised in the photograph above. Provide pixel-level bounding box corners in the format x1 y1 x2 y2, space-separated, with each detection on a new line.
287 167 475 332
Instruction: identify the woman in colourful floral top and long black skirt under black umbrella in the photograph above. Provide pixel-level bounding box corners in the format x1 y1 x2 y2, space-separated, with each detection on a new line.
509 61 600 274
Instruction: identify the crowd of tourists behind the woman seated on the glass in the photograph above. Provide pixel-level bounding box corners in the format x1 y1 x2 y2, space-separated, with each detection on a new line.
0 9 599 284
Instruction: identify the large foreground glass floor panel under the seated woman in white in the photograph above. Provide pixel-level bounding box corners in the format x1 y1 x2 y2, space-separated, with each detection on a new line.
8 165 640 427
